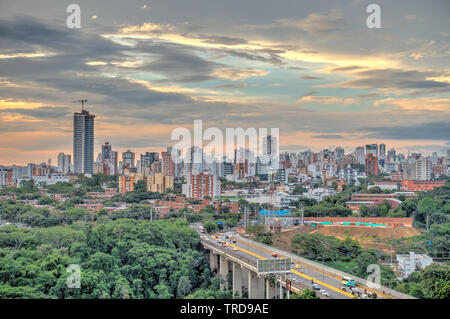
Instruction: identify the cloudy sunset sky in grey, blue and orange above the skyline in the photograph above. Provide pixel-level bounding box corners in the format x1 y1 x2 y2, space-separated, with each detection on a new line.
0 0 450 165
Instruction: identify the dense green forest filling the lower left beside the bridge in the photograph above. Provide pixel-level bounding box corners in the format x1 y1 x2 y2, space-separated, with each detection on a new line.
0 219 230 299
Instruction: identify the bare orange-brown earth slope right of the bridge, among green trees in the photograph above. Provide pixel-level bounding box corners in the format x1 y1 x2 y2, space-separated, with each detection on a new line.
273 226 420 252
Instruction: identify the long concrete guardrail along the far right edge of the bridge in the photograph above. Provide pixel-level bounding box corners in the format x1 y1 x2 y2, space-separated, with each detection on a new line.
233 234 417 299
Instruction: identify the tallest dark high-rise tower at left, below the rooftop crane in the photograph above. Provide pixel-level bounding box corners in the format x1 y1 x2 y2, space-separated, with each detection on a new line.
73 109 95 174
